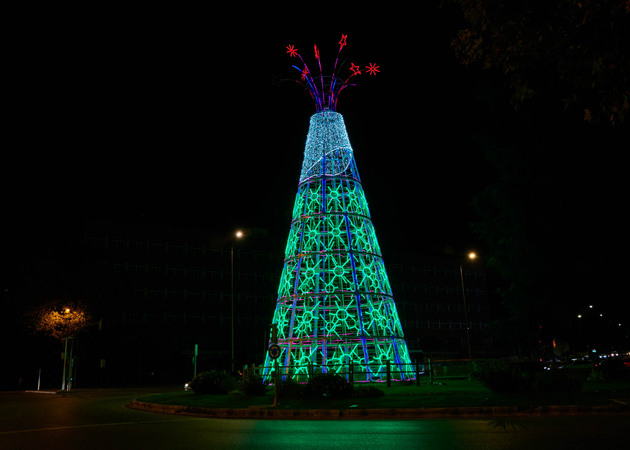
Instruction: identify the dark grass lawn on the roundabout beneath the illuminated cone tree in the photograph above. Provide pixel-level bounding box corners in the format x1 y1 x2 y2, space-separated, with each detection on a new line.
137 379 630 409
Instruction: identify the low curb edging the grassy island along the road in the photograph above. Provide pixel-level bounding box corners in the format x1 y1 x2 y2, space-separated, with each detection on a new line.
126 400 630 420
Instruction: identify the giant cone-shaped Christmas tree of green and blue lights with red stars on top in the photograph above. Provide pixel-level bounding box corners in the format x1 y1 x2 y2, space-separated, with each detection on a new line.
265 35 414 380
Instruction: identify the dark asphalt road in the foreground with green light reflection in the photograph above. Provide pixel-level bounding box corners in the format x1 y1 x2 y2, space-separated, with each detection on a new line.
0 389 630 450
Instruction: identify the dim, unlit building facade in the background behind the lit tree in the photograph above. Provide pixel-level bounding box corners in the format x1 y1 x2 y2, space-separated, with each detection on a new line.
79 221 491 385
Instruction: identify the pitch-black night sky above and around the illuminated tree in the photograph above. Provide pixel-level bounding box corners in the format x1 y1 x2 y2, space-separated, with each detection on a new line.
0 0 630 370
